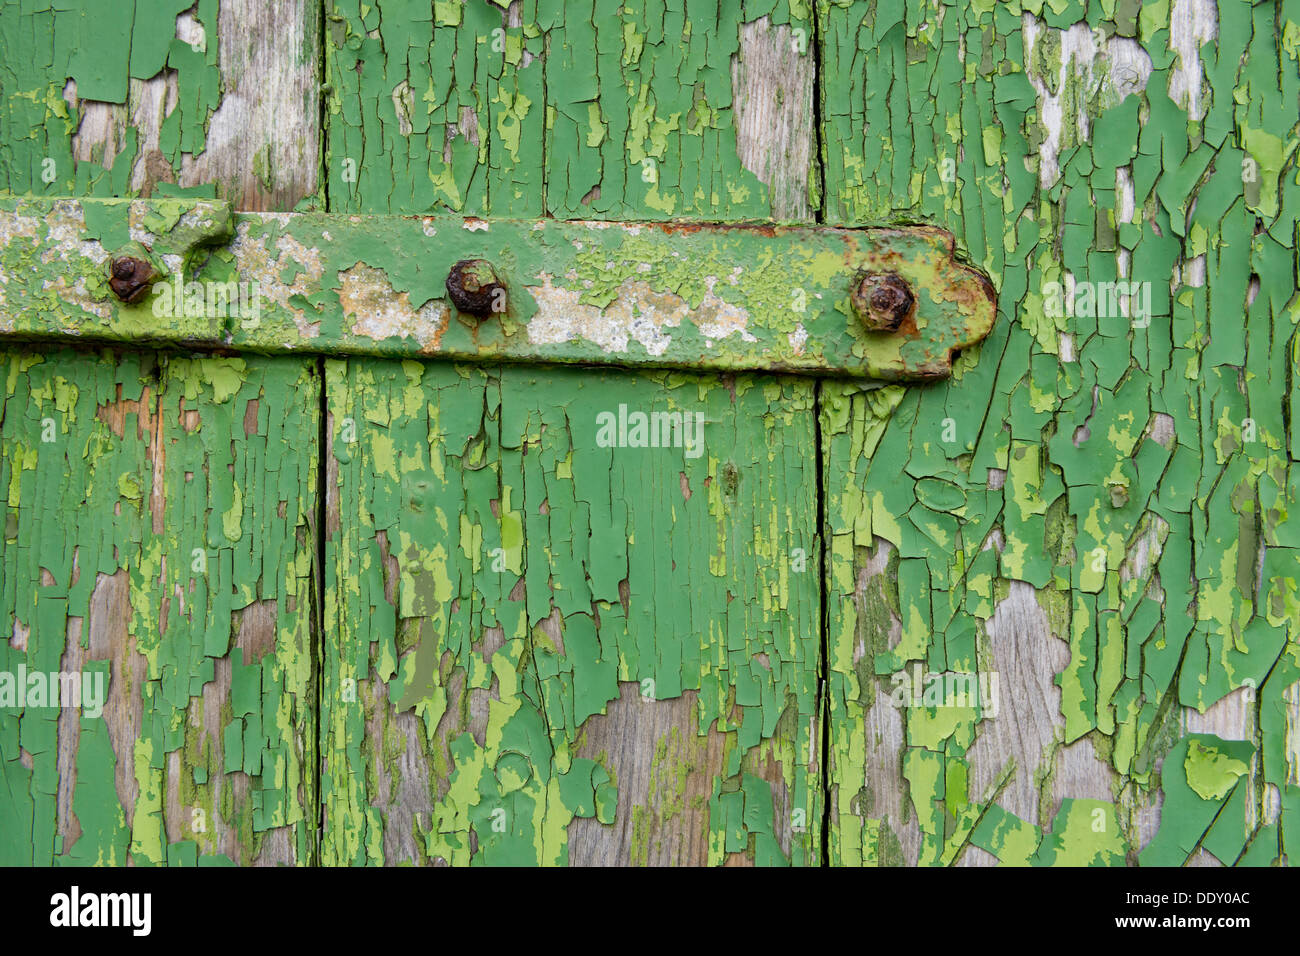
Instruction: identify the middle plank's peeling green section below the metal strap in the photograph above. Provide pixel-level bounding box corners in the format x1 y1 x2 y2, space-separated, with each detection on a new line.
321 360 820 865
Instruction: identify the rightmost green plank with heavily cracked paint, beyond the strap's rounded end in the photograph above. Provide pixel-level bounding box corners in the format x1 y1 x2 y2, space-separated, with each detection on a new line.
818 0 1300 865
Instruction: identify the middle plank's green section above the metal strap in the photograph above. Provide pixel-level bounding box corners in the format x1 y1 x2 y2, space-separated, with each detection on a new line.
326 0 816 220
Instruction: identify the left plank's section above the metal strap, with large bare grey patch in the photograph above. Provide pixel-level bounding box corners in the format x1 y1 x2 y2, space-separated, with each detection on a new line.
0 0 321 209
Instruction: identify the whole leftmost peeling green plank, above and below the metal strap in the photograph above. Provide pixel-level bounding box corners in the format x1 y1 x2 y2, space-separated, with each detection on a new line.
0 0 321 865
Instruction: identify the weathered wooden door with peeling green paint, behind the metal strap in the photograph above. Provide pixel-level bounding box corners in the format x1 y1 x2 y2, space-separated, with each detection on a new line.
0 0 1300 865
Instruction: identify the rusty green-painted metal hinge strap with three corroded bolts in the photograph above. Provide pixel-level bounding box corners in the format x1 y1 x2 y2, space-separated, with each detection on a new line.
0 198 996 380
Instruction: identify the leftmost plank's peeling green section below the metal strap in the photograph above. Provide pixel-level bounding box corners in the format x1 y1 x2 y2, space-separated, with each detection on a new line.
0 351 319 865
